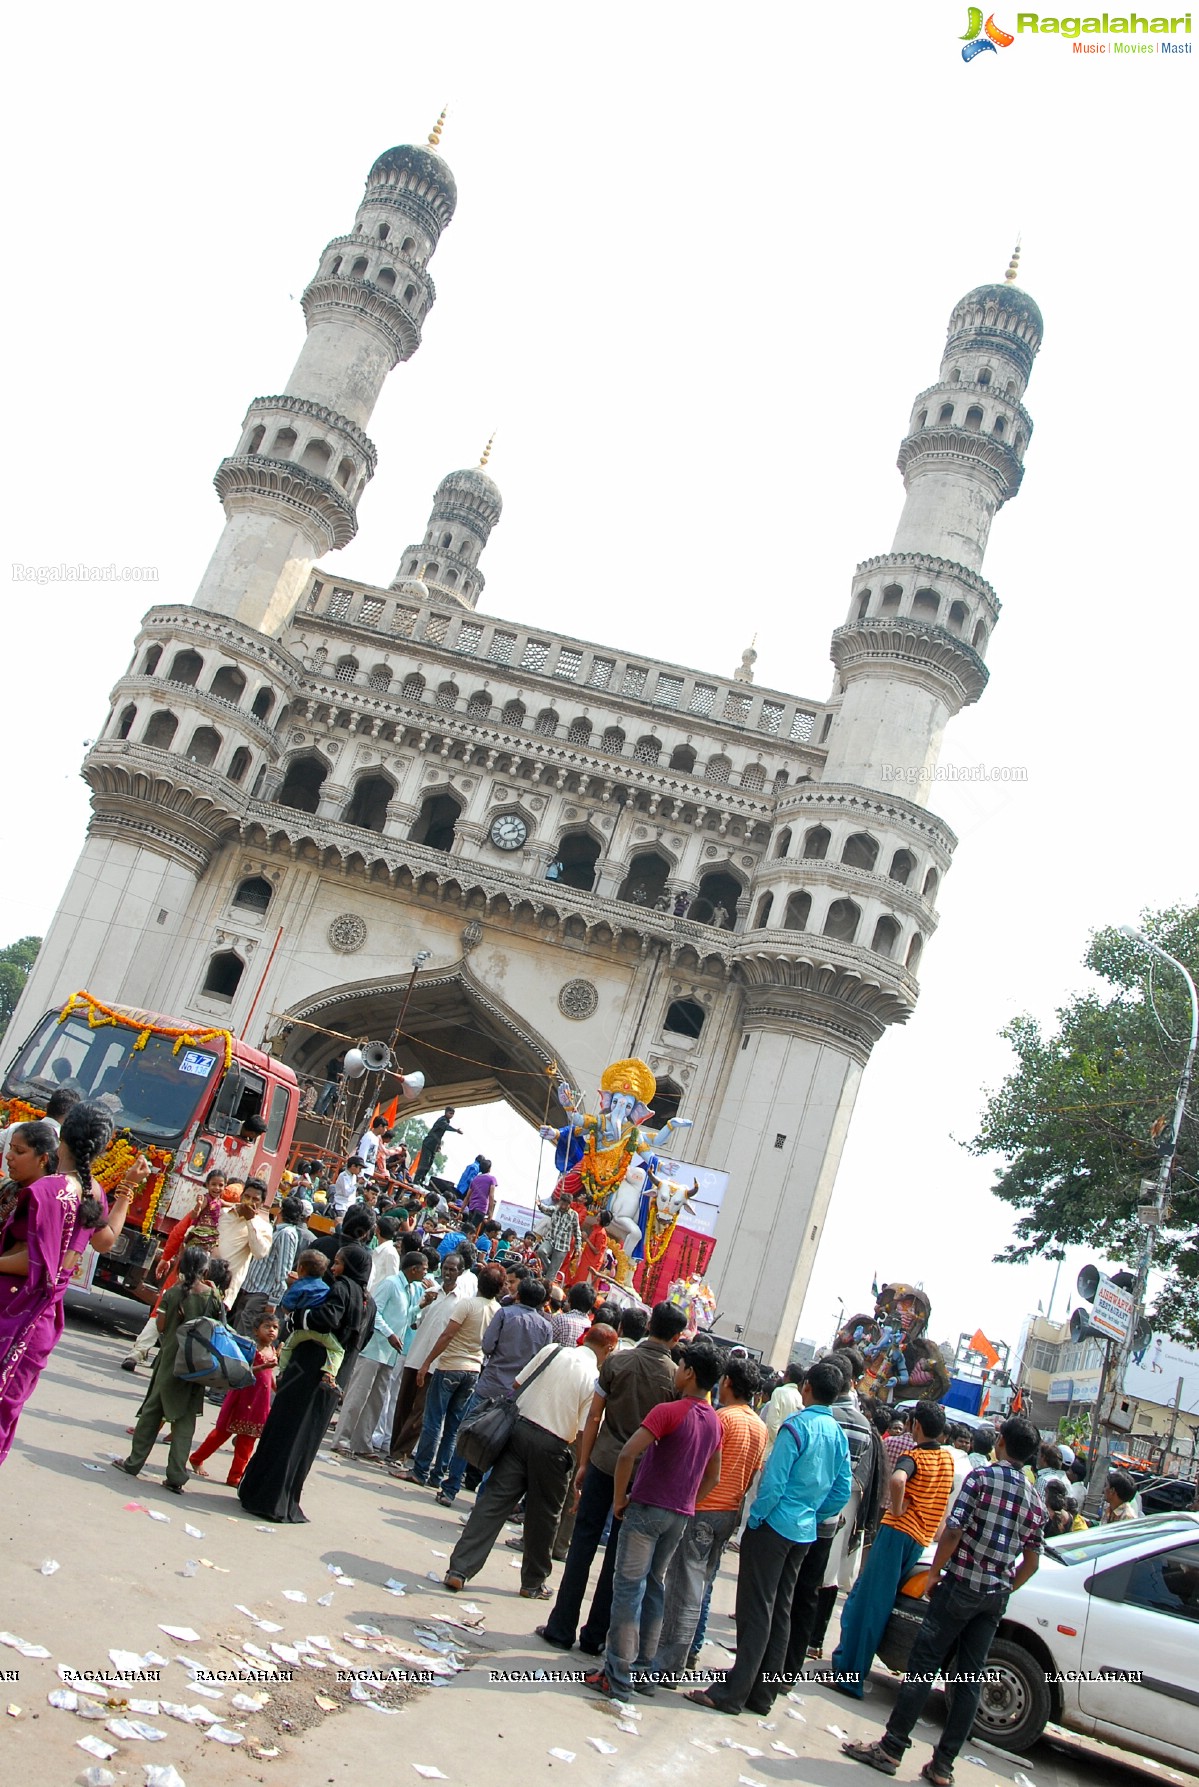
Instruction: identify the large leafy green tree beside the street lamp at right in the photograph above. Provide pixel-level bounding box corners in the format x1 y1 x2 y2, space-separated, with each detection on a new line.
965 906 1199 1346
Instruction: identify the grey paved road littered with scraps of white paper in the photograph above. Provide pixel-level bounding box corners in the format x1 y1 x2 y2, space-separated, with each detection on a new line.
0 1299 1194 1787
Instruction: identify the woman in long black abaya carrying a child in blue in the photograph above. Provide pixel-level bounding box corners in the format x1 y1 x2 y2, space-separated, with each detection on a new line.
238 1246 375 1524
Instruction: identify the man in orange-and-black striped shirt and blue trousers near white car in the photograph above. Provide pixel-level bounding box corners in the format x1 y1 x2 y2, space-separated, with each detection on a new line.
829 1403 954 1699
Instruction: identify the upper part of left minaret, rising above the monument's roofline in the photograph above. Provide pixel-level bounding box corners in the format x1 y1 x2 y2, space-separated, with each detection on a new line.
195 114 457 633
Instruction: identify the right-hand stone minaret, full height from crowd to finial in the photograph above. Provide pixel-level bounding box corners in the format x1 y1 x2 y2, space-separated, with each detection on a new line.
708 256 1042 1363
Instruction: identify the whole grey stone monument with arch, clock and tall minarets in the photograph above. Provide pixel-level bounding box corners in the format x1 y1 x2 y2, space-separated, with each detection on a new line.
4 132 1042 1362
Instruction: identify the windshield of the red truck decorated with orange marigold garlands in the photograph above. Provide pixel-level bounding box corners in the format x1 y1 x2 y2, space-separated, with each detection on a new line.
4 1013 218 1142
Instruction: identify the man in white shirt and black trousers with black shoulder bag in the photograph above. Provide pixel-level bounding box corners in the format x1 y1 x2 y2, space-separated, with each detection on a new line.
445 1322 616 1601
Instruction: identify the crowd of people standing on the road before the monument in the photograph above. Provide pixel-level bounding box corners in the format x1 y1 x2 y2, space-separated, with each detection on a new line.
0 1101 1157 1787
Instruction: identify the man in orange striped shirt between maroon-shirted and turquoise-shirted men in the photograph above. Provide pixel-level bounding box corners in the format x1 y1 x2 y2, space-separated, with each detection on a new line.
647 1358 767 1685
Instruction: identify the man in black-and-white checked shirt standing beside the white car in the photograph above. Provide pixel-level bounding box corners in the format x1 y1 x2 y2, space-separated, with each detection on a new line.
842 1417 1047 1787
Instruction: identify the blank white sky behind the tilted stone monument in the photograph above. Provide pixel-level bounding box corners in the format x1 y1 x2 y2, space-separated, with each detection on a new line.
0 0 1195 1342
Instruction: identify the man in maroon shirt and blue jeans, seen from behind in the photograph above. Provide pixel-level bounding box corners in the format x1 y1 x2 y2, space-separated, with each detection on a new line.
584 1340 724 1701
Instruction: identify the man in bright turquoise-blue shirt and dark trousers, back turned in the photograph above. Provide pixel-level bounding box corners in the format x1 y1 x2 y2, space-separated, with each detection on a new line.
688 1360 854 1716
